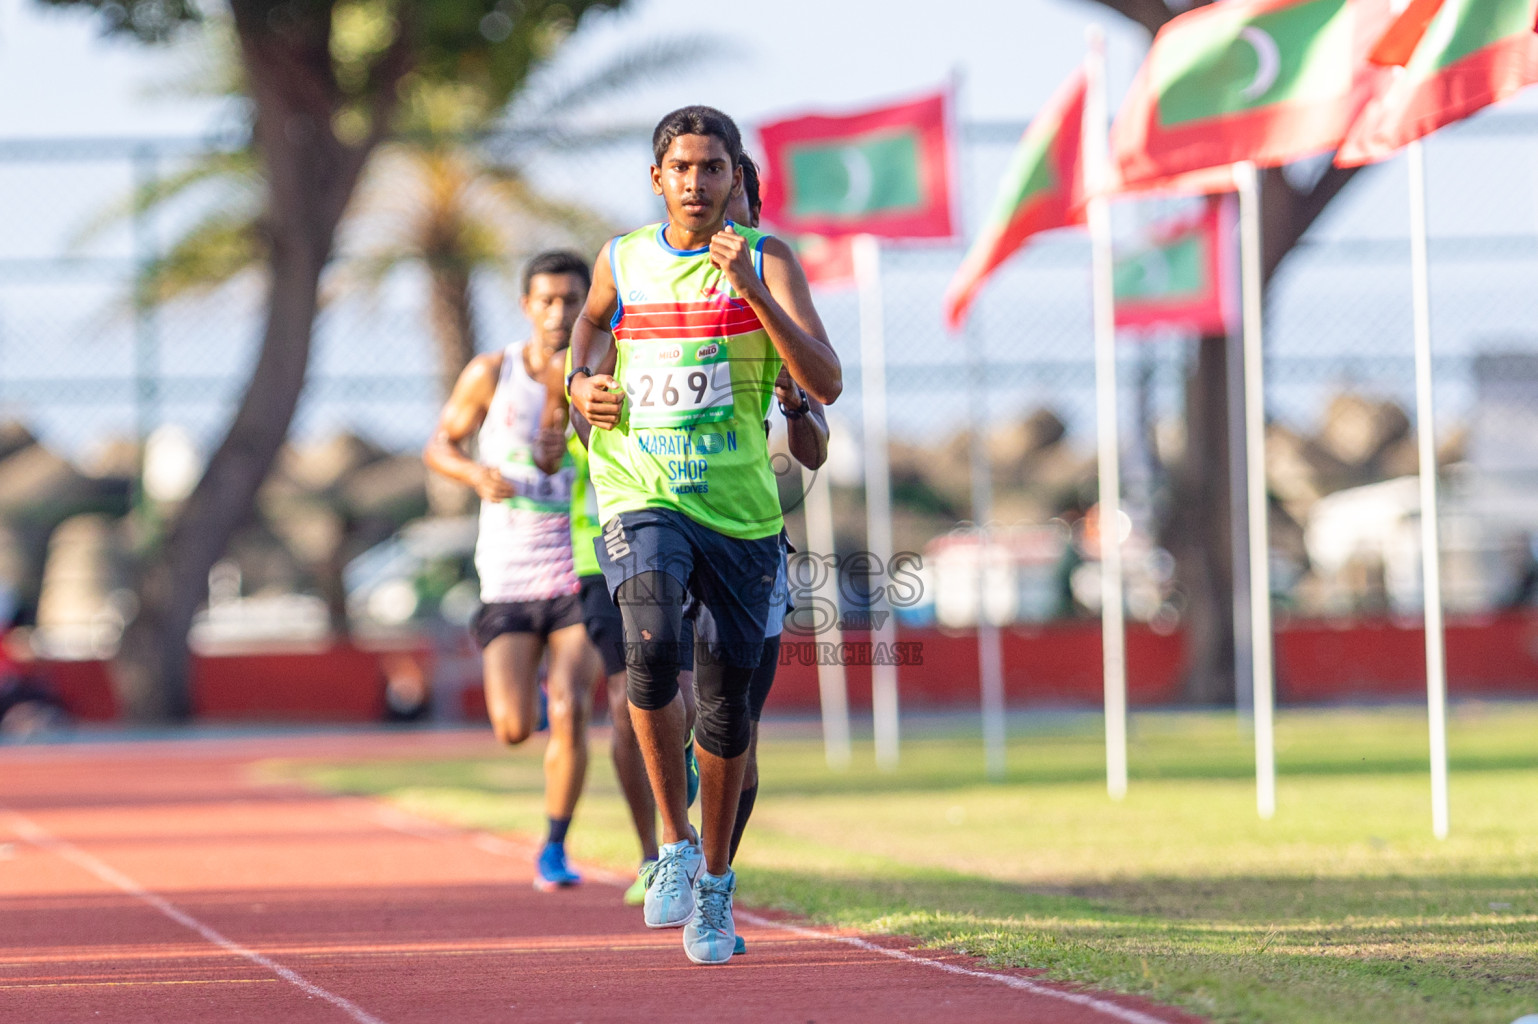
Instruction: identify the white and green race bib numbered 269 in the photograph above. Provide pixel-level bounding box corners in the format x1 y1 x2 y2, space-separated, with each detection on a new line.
624 341 732 427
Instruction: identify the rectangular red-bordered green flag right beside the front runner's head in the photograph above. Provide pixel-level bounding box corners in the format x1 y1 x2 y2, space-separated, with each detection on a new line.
758 94 955 238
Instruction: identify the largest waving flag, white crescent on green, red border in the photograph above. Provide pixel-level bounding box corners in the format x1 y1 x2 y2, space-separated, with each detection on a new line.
1110 0 1390 188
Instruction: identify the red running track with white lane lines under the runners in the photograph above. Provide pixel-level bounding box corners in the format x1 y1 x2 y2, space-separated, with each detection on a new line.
0 733 1197 1024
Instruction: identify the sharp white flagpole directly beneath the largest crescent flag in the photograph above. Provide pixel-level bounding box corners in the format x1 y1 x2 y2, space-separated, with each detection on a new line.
1233 161 1277 821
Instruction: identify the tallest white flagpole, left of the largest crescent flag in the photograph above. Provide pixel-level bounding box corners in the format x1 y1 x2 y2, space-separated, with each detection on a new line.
1083 25 1127 800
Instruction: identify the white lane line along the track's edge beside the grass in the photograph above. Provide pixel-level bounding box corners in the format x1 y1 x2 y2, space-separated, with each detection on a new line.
353 801 1169 1024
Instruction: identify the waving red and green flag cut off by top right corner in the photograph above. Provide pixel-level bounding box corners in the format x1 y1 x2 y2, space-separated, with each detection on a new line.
1335 0 1538 168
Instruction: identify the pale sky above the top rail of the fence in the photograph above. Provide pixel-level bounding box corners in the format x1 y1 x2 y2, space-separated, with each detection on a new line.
0 0 1143 138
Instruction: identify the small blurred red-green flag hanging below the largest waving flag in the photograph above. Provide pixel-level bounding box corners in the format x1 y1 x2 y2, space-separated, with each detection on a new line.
1114 197 1238 337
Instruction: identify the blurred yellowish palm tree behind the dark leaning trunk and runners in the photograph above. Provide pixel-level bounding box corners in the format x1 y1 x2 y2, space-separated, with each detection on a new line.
119 38 707 398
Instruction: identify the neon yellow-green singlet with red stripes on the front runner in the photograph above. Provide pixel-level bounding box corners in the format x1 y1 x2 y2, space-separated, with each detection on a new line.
589 224 783 540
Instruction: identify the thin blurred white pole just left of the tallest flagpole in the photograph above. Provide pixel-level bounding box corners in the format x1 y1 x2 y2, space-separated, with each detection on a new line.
964 322 1007 783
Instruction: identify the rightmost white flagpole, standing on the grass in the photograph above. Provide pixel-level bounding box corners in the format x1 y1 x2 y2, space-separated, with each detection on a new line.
1409 138 1447 839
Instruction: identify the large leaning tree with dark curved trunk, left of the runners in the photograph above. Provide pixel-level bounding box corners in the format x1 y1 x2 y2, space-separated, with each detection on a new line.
54 0 624 720
